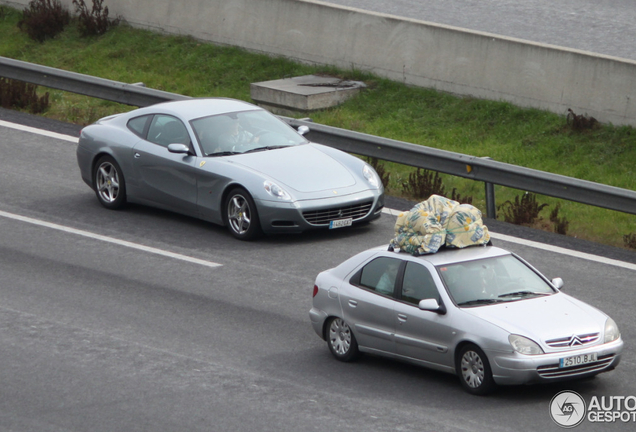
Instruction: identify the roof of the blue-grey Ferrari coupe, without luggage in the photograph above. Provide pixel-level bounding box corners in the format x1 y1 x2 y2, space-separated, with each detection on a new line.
134 98 262 121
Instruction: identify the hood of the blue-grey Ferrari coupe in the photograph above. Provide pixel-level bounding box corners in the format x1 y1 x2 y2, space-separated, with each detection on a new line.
233 144 356 193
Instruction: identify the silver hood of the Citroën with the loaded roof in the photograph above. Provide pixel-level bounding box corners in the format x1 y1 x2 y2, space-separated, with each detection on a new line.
464 293 606 344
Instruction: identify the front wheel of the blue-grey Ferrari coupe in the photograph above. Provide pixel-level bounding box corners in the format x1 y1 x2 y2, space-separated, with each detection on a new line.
225 188 261 240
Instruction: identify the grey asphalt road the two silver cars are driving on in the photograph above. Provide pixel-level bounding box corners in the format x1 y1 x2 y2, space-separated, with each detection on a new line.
0 111 636 431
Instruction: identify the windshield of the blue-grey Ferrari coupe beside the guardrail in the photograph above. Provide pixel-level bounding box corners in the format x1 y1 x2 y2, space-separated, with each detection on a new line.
190 110 307 156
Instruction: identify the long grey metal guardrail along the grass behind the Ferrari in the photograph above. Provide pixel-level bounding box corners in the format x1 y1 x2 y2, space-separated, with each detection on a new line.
0 57 636 218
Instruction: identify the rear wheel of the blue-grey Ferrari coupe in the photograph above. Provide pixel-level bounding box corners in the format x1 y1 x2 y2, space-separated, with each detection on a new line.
93 156 126 210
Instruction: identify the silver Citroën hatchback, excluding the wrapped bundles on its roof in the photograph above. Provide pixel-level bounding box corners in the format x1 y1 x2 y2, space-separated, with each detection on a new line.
309 246 623 394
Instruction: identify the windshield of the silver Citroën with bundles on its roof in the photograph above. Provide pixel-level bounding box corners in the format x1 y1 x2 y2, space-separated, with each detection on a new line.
437 255 555 306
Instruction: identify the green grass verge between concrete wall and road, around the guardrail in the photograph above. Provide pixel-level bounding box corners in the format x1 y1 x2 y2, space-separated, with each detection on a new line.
0 7 636 247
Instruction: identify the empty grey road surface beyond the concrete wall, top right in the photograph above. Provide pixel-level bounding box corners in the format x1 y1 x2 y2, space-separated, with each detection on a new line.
328 0 636 60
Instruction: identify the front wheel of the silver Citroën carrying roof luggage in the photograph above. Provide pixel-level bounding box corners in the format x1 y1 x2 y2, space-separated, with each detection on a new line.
457 344 495 395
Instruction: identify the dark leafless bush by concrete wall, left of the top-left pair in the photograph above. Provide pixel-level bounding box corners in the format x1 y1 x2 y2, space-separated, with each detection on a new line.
18 0 71 42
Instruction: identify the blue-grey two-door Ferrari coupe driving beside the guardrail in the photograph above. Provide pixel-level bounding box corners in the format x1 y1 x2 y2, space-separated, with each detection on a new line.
77 98 384 240
